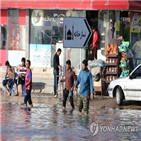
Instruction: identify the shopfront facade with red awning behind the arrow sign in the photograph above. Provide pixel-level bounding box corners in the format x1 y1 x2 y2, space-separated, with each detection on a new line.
0 0 141 69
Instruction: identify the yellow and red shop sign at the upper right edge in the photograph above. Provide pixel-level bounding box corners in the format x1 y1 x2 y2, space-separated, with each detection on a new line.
130 13 141 33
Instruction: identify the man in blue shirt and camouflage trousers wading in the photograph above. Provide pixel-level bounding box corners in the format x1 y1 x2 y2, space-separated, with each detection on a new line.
74 60 94 115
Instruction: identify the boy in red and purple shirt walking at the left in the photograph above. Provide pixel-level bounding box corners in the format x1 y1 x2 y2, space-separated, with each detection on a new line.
24 60 33 108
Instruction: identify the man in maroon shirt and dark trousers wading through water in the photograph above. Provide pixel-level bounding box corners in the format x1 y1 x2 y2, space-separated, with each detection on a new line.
61 60 76 110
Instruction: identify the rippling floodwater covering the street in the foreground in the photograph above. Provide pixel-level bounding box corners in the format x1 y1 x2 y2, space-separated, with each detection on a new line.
0 103 141 141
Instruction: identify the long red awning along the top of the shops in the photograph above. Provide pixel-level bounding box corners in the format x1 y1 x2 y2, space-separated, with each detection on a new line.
0 0 141 11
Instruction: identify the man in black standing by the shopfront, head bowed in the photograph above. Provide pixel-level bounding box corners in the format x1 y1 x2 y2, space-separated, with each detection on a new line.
53 48 61 97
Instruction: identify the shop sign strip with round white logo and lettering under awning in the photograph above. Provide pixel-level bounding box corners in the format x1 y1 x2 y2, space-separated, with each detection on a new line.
31 9 86 26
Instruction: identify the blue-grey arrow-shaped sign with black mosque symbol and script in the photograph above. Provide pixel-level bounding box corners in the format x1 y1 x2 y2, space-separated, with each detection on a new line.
64 18 92 48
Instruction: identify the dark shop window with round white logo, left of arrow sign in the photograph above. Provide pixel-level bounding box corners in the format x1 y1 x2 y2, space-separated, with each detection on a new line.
30 10 65 44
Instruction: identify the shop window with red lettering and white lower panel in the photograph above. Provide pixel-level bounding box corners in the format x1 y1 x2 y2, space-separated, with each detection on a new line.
7 9 26 66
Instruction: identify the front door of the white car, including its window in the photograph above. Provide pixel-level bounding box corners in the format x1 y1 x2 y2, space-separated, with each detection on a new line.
125 66 141 100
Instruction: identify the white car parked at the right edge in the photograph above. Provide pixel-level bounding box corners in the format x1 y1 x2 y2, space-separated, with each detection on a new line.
108 64 141 105
